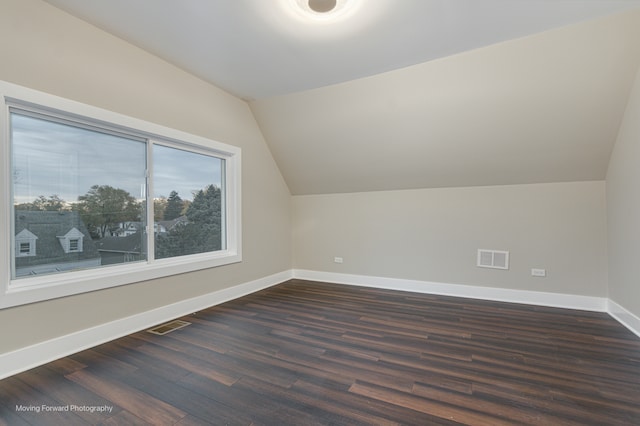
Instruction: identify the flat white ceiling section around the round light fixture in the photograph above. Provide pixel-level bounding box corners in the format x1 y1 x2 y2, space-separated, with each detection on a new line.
42 0 640 100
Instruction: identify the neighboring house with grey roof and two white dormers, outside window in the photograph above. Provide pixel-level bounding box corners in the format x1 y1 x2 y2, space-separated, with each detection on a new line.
15 210 101 277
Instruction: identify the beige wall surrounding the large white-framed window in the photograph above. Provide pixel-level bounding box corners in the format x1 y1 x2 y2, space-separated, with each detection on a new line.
0 0 291 353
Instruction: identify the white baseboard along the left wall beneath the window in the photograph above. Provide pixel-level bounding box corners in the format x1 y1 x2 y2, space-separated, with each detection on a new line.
0 270 292 379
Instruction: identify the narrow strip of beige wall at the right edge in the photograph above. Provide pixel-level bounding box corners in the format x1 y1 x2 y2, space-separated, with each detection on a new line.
607 62 640 317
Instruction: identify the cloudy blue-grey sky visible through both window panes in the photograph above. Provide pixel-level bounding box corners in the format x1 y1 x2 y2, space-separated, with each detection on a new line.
11 113 223 203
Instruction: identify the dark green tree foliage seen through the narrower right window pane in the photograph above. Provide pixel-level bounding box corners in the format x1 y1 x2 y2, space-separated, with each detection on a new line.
155 185 222 259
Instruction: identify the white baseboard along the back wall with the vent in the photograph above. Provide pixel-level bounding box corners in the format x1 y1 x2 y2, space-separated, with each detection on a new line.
293 269 607 312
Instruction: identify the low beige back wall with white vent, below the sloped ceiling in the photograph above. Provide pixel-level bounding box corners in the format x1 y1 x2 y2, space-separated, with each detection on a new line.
292 181 607 297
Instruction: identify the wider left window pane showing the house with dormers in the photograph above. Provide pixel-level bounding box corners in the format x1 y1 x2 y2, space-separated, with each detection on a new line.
11 111 147 278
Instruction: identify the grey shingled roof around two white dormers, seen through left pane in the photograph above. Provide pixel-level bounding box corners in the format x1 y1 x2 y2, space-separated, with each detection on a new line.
15 210 100 268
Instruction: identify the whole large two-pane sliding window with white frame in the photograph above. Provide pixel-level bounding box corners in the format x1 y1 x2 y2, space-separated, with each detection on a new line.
0 82 241 307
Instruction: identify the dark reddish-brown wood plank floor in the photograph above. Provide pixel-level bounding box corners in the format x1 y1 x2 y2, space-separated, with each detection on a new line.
0 280 640 426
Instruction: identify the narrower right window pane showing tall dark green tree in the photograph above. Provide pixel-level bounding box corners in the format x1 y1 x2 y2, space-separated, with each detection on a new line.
153 145 226 259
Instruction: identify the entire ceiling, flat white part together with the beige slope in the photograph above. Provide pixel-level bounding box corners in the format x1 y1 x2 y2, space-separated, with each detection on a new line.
47 0 640 194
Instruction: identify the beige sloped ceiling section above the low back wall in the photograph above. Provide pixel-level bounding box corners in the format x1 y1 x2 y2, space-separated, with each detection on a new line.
251 11 640 194
